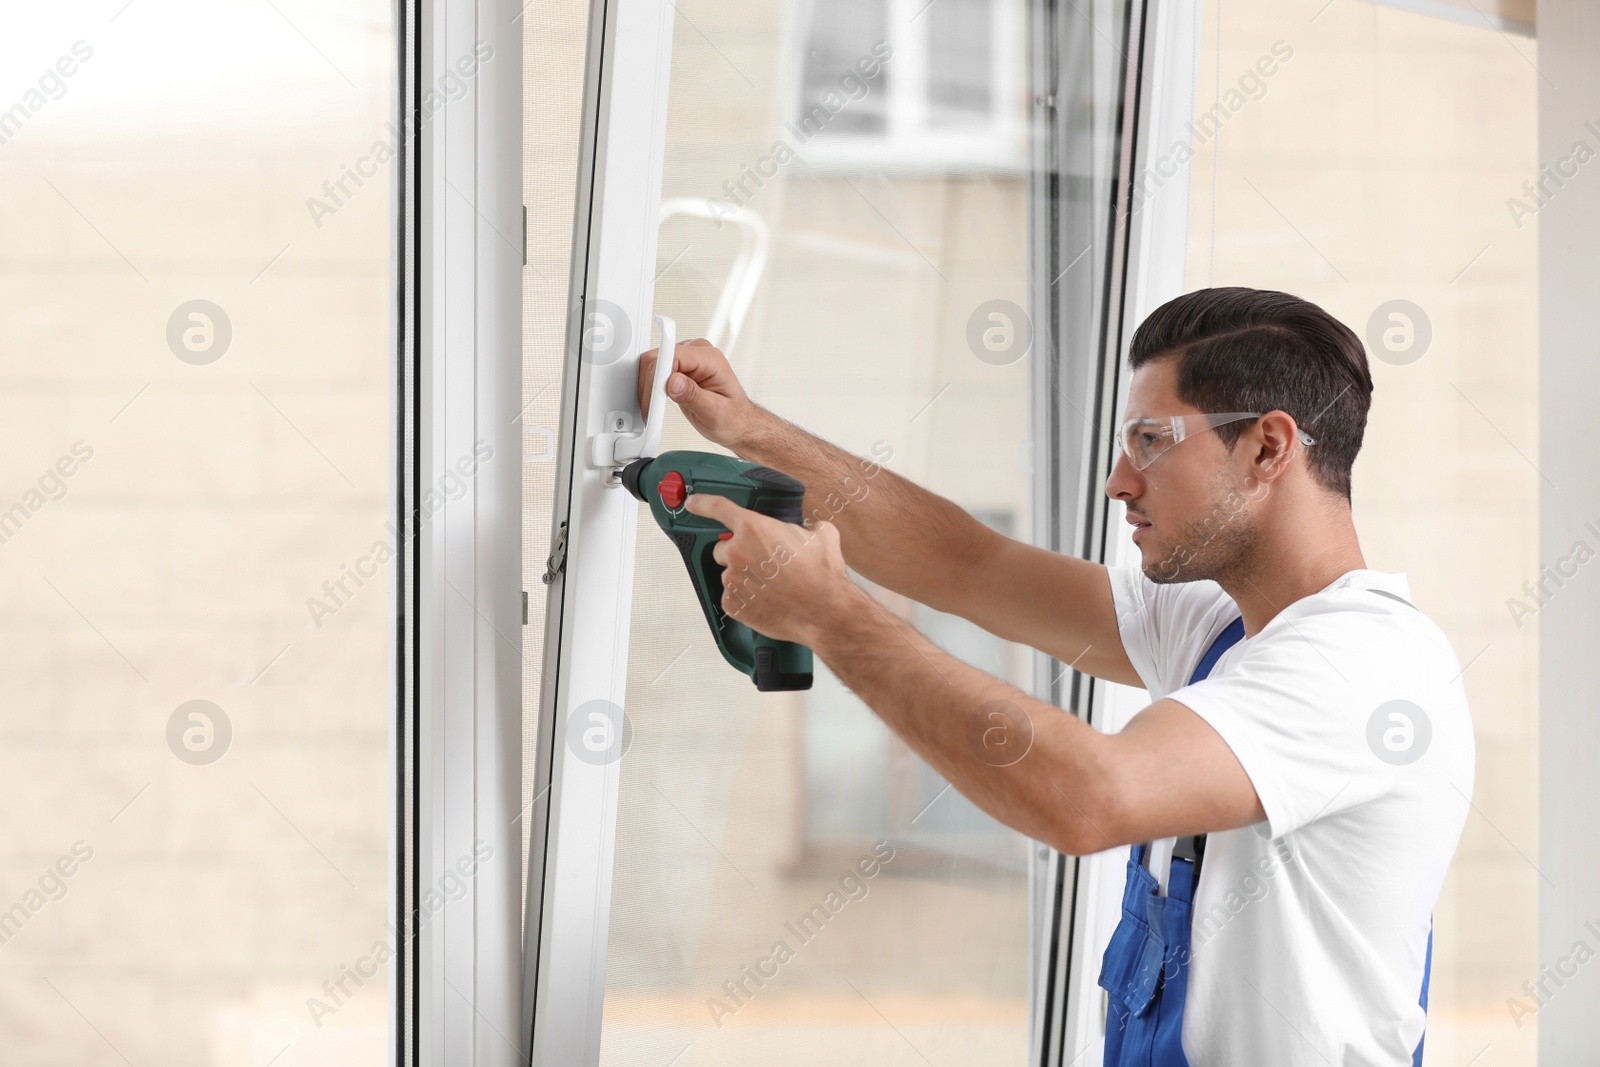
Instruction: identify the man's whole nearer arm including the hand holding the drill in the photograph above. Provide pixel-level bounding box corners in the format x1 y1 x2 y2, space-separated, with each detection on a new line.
683 493 1266 856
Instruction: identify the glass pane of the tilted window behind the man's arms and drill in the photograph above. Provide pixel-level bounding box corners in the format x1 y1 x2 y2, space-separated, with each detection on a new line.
602 0 1032 1067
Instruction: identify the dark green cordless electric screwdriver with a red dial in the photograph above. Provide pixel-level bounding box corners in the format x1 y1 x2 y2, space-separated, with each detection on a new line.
621 450 811 693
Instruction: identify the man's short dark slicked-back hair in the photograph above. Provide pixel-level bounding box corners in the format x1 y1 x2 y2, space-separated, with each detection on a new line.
1128 286 1373 501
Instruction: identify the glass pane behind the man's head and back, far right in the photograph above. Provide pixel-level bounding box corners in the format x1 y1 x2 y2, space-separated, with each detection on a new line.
1189 0 1536 1067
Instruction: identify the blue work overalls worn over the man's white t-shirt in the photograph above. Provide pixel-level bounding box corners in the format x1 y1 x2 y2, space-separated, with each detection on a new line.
1099 619 1434 1067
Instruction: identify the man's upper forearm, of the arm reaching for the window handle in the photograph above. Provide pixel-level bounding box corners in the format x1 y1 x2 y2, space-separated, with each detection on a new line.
734 408 986 608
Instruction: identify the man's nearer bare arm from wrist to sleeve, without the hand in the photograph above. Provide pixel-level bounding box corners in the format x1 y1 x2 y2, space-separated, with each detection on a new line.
808 585 1266 856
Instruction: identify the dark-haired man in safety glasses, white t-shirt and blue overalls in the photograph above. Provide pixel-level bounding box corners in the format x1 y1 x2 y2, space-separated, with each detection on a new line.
640 288 1474 1067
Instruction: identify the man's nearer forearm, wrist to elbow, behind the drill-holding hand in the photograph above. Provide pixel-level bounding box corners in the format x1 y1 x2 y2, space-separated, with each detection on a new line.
811 584 1117 854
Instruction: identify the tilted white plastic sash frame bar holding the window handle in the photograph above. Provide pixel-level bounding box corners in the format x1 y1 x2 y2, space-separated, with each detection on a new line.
518 0 674 1065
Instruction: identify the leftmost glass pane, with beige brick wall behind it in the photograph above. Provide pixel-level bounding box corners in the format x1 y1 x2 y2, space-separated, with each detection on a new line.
0 0 397 1067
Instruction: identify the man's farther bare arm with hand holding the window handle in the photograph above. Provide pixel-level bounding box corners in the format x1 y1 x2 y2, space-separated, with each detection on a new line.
640 342 1144 686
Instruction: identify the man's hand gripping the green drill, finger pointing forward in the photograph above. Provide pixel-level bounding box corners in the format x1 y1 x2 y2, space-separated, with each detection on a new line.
685 489 866 646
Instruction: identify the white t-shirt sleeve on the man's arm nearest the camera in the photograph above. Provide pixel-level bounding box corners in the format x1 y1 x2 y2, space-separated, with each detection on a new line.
1168 616 1395 838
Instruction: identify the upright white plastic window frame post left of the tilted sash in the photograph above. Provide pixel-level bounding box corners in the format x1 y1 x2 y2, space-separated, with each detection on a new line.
400 0 528 1067
